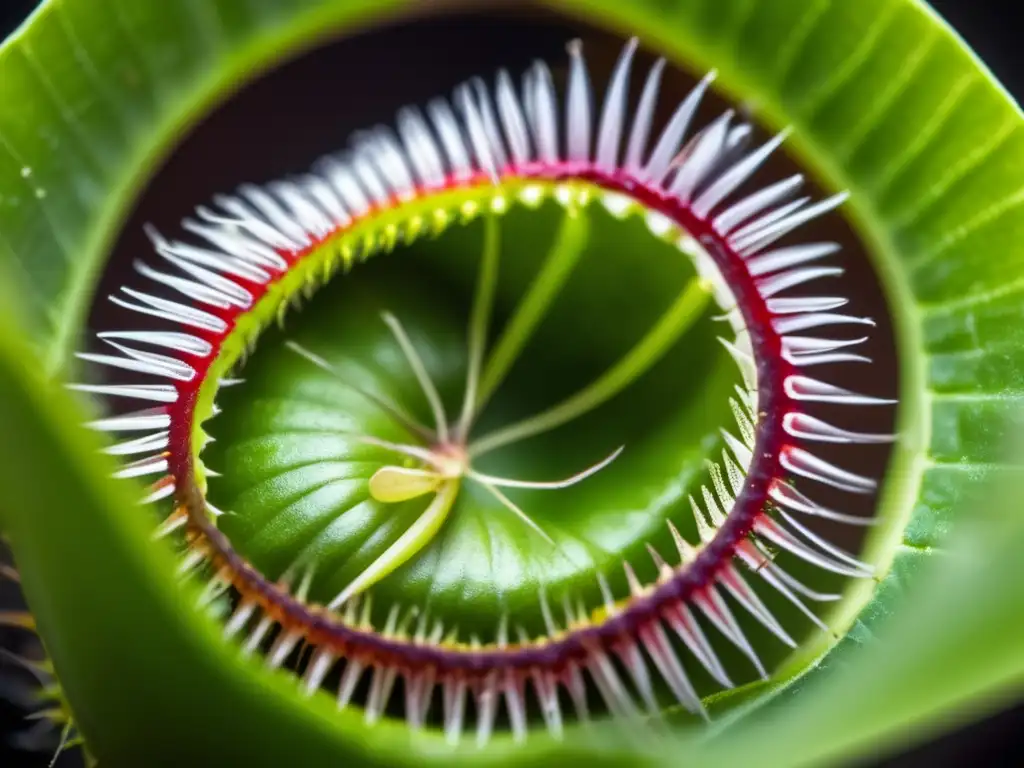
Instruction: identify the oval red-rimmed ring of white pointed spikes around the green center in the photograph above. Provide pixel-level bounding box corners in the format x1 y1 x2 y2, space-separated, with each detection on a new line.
78 41 891 743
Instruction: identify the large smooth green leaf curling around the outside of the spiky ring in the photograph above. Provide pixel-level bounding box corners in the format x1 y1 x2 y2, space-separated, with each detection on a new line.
0 0 1024 765
